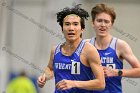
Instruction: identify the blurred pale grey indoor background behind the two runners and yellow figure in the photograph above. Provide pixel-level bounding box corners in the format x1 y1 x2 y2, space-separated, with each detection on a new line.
0 0 140 93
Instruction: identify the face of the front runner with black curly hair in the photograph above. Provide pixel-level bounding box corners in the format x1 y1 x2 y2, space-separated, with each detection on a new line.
63 14 83 41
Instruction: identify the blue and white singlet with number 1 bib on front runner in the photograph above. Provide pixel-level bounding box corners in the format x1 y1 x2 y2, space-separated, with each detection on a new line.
53 40 93 93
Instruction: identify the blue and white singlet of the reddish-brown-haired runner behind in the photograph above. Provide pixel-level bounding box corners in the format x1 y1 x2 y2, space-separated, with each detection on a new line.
90 37 123 93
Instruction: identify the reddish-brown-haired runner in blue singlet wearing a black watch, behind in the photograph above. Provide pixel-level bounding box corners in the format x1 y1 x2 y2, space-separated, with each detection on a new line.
89 4 140 93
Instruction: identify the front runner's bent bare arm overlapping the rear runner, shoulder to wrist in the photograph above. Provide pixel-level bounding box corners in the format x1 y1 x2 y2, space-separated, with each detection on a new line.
75 44 105 90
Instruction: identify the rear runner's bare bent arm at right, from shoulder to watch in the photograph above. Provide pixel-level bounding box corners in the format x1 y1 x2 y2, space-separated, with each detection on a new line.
117 40 140 78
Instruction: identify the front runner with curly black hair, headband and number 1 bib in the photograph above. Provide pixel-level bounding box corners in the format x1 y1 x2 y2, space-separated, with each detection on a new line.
38 5 105 93
